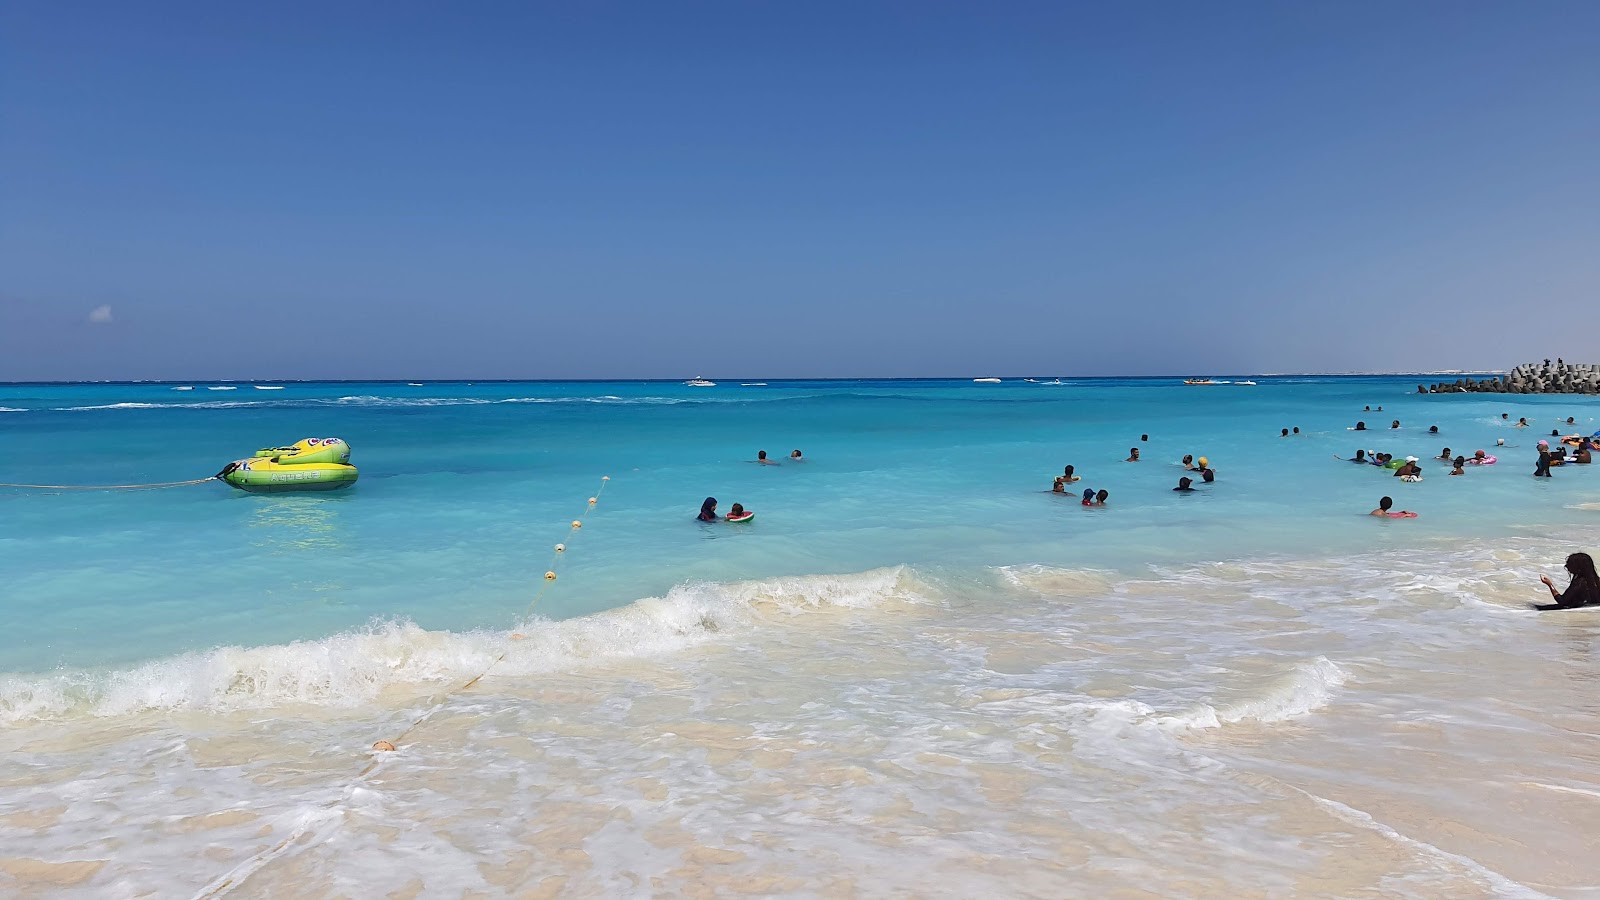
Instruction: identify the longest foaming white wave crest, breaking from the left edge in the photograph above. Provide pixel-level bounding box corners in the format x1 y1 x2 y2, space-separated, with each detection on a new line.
0 567 922 725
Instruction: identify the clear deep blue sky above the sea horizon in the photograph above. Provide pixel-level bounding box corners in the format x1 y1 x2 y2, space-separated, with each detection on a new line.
0 0 1600 380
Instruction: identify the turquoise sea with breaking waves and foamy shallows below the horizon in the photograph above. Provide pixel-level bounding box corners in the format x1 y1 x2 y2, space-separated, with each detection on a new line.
0 376 1600 897
